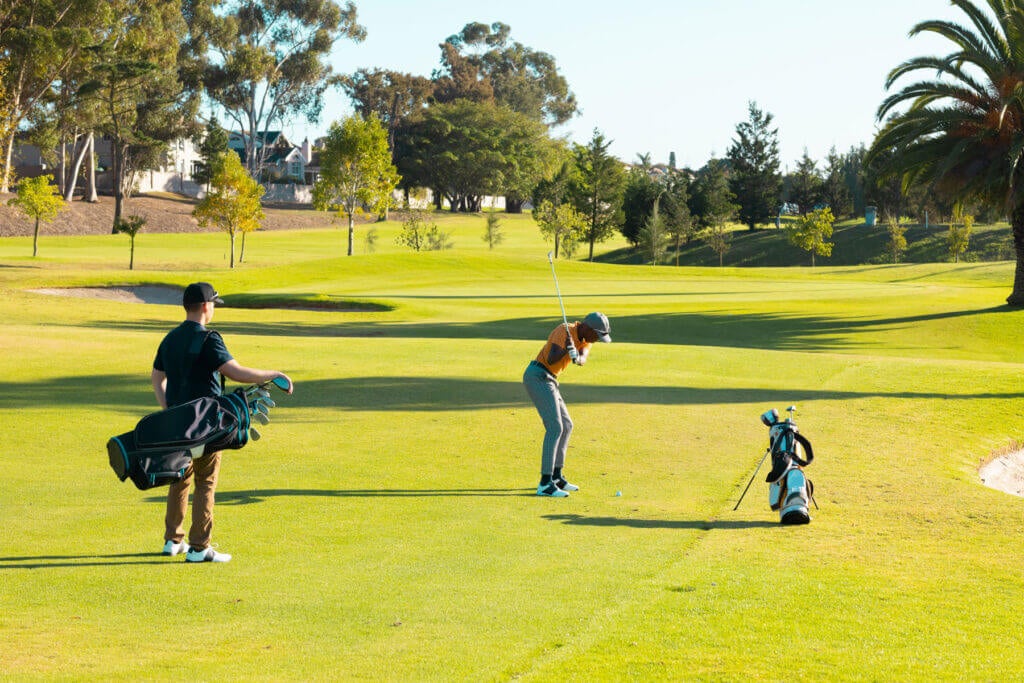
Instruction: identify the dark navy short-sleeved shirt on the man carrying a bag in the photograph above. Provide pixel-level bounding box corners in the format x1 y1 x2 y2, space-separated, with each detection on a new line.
153 321 232 408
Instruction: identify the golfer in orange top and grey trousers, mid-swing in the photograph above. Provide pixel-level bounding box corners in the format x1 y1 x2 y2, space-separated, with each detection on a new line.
522 312 611 498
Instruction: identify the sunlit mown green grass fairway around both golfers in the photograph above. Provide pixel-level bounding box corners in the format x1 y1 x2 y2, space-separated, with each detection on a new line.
0 218 1024 681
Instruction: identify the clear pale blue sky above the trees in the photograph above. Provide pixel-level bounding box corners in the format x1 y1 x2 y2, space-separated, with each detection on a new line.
285 0 966 168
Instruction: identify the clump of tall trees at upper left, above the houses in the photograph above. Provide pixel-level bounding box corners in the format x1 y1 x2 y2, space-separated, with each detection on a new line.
0 0 366 232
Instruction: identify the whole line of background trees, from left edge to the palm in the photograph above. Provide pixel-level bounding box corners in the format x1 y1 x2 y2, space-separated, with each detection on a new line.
9 0 1024 290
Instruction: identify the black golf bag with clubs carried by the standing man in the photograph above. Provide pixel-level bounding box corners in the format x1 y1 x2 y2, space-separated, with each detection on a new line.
106 382 284 490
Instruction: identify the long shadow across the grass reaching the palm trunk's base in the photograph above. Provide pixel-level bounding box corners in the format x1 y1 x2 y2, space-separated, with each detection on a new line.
79 307 1017 351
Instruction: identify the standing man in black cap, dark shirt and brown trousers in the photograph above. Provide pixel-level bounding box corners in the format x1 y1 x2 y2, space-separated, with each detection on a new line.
151 283 292 562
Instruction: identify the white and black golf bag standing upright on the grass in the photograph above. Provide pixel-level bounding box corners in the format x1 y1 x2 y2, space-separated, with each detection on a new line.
761 409 816 524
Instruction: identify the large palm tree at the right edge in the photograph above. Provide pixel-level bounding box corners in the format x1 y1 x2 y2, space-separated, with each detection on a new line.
867 0 1024 306
